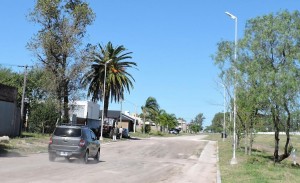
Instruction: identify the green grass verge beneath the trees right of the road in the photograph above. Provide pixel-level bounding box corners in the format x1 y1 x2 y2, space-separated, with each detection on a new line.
207 134 300 183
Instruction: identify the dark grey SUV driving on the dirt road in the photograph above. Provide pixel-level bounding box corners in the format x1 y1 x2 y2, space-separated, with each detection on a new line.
48 125 100 163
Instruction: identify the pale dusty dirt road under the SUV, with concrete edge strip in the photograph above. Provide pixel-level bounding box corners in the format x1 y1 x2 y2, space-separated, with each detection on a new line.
0 135 217 183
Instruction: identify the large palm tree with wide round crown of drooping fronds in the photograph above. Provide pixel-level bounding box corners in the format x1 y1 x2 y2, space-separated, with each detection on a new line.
81 42 137 117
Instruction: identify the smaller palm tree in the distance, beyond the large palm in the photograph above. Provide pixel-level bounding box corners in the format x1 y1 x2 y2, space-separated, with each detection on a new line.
141 97 159 133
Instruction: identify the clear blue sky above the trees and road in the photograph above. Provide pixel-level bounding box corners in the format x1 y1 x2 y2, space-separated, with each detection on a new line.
0 0 299 126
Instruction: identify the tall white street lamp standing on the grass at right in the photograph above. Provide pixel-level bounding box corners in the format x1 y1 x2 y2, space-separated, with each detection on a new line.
225 11 237 165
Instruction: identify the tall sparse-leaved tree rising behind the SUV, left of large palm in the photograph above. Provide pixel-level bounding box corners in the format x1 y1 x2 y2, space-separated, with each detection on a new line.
28 0 95 121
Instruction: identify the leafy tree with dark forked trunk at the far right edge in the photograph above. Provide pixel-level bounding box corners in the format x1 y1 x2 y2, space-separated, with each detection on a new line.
244 11 300 162
